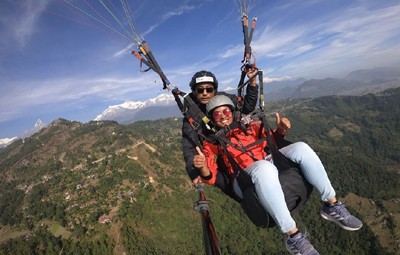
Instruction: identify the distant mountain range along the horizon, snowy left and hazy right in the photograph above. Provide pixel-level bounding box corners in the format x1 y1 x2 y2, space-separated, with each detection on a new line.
0 67 400 148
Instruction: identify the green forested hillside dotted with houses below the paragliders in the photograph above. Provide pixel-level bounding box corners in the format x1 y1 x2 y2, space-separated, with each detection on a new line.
0 89 400 255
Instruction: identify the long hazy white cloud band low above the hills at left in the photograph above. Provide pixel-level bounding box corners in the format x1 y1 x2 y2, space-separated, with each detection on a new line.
0 75 159 122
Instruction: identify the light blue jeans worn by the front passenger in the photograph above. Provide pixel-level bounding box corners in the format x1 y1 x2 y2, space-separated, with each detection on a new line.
234 142 336 233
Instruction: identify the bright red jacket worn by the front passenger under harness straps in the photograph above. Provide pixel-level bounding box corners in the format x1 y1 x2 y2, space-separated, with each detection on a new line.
203 122 267 185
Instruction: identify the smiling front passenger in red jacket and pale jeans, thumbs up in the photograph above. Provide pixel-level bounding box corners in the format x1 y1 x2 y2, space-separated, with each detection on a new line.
193 95 362 254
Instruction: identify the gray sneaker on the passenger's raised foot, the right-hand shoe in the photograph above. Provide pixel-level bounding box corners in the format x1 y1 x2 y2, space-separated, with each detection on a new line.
320 202 362 231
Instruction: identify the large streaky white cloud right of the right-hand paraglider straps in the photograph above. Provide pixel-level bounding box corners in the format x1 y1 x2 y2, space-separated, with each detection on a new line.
253 2 400 76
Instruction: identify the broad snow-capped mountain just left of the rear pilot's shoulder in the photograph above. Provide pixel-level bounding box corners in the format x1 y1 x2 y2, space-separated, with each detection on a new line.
94 94 179 124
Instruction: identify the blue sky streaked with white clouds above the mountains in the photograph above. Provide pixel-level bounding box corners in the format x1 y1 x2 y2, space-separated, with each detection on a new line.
0 0 400 138
